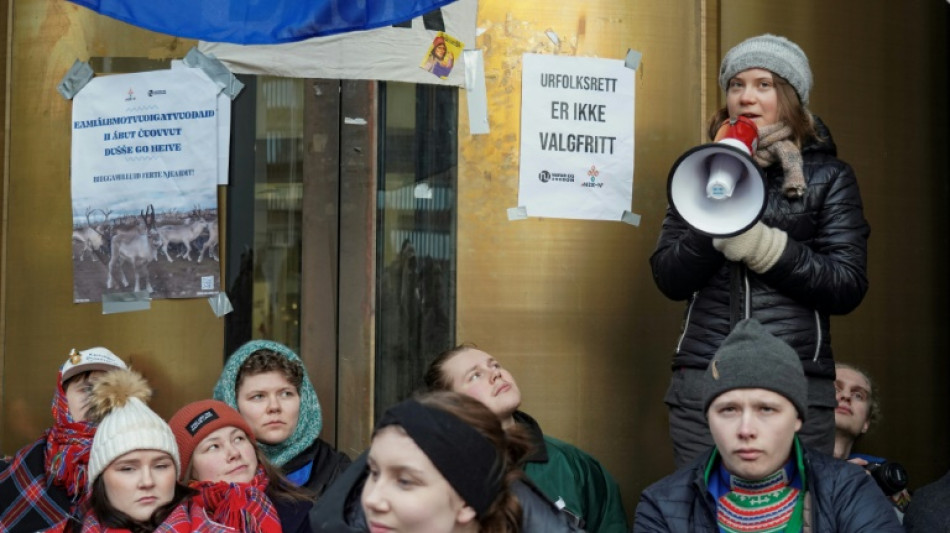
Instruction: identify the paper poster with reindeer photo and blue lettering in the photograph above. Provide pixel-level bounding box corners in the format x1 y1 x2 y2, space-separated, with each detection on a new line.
71 68 221 302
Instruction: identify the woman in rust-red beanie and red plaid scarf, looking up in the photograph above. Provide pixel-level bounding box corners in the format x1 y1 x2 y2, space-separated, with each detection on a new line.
168 400 313 533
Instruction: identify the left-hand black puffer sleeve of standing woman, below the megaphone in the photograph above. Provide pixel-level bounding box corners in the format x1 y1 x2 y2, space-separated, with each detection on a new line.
650 208 726 300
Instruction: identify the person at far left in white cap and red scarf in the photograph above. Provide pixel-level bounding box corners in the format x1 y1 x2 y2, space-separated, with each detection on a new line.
0 347 126 533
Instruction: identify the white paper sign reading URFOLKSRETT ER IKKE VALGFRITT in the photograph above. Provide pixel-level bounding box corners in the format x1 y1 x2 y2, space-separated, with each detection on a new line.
518 54 634 220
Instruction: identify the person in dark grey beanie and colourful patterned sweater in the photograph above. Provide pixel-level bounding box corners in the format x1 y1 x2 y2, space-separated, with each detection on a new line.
633 319 903 533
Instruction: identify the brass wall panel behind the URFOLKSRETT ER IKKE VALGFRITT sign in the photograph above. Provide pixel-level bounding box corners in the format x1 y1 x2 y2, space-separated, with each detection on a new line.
457 0 706 513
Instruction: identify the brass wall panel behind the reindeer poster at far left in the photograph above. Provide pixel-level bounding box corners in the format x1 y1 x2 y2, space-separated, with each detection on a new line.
0 0 223 453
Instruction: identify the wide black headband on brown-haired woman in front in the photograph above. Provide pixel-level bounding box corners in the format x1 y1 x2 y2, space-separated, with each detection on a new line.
376 400 504 517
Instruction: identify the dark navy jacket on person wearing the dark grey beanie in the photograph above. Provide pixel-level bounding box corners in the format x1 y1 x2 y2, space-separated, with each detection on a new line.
633 448 904 533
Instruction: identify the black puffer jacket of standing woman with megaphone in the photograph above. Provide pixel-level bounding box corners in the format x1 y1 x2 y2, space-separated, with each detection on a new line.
650 117 870 379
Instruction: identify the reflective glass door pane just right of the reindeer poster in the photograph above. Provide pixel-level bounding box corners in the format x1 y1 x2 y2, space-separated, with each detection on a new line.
227 76 304 353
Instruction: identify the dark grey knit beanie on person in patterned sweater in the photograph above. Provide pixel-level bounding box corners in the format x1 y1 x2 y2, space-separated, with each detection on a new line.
703 318 808 420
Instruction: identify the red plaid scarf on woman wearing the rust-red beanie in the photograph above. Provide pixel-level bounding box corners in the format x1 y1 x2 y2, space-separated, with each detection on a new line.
189 465 281 533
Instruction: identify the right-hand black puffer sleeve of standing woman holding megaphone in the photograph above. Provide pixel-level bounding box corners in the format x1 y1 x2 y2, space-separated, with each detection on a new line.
761 160 871 314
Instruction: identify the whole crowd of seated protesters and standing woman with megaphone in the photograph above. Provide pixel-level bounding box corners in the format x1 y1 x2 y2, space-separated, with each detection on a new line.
0 34 950 533
